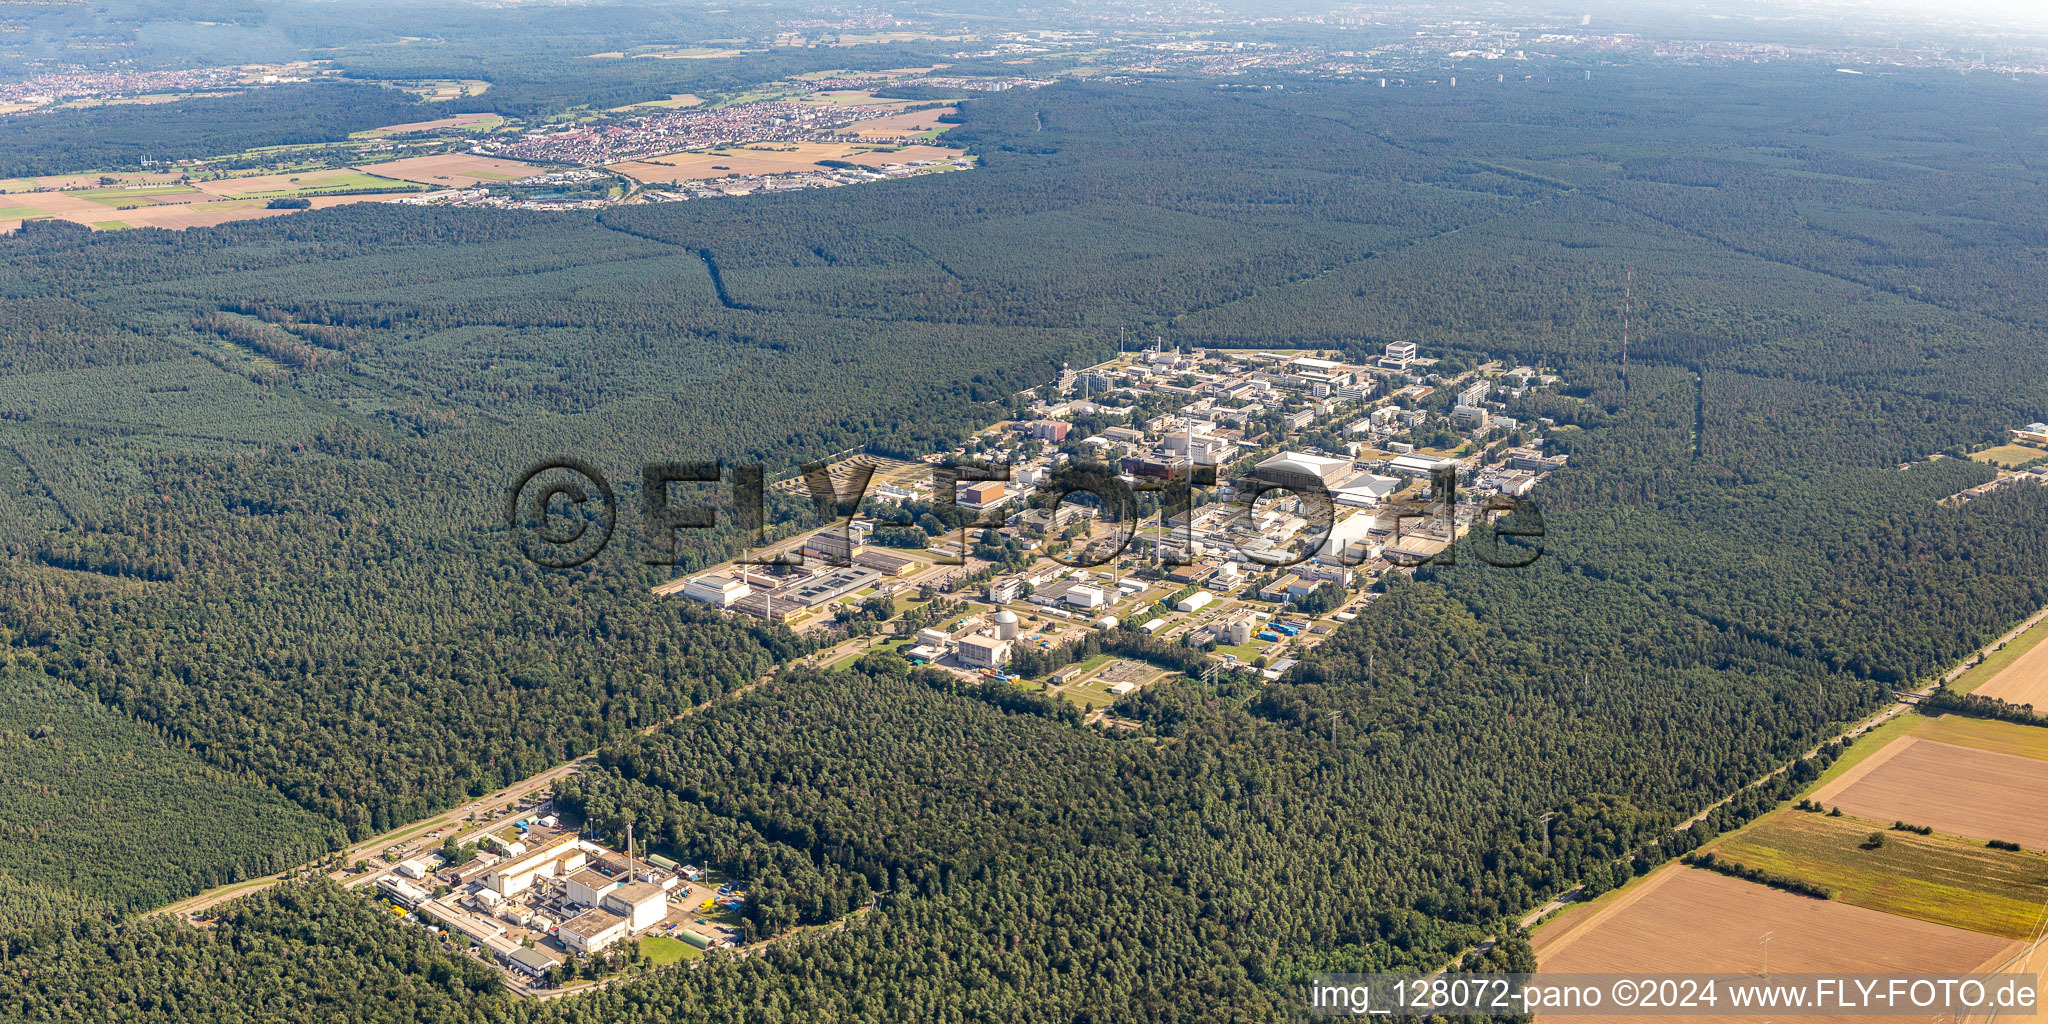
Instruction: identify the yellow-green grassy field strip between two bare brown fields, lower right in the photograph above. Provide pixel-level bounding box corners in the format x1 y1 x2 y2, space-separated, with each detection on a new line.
1712 811 2048 938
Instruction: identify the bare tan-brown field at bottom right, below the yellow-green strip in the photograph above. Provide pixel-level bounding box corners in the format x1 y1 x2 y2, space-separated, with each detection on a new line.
1534 864 2023 1024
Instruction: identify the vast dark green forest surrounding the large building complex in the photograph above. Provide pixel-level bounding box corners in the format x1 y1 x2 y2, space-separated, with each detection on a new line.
0 61 2048 1022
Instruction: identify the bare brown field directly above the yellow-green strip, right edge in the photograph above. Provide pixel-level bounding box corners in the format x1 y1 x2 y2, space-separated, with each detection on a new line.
1812 737 2048 848
